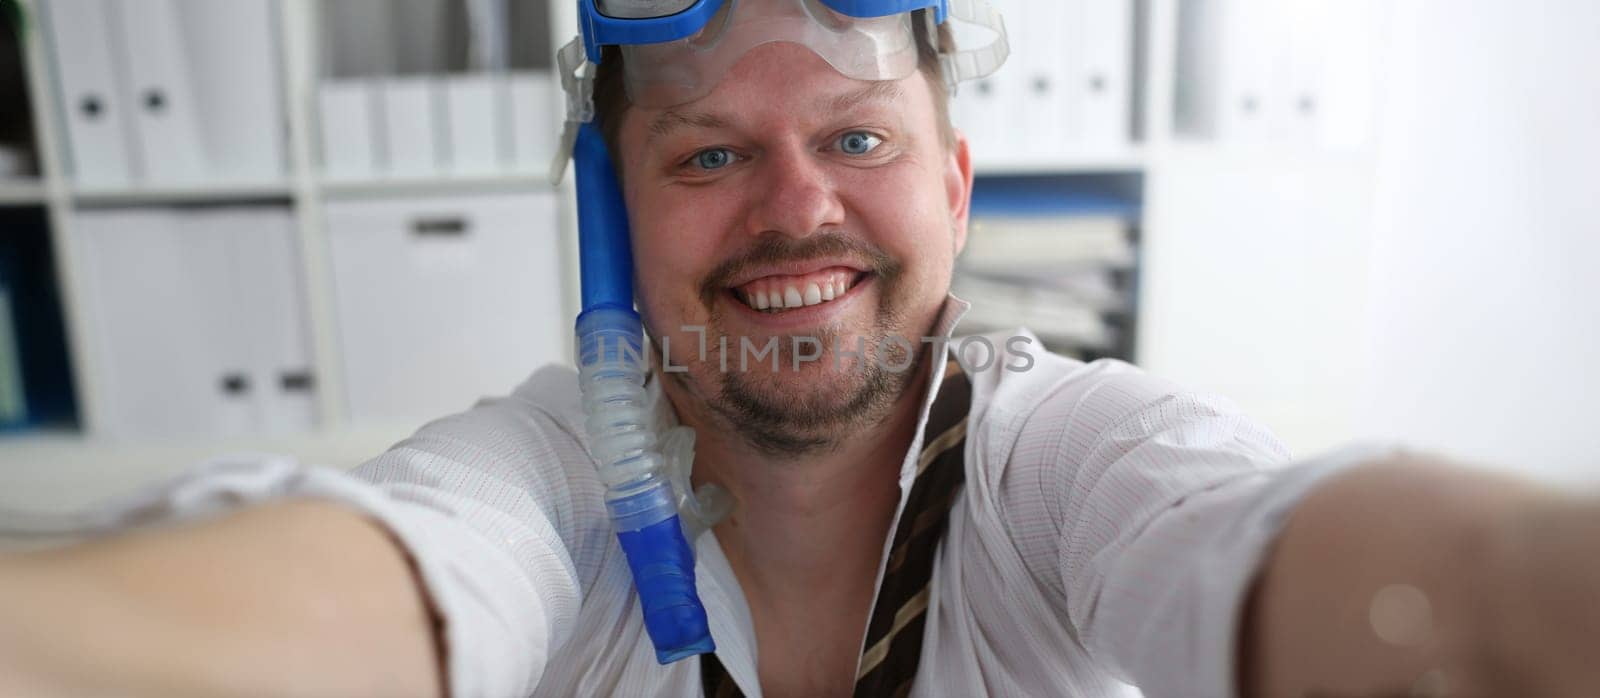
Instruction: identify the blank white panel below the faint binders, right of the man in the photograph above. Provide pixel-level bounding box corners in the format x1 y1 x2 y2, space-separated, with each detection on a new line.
1136 146 1371 455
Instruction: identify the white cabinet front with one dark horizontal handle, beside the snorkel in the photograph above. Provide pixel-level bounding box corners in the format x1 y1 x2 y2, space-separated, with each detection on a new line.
326 192 573 424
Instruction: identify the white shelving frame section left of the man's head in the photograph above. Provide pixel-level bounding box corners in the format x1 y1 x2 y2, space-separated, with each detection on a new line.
0 0 576 474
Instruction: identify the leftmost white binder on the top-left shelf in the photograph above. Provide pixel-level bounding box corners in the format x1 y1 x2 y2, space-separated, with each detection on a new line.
43 0 134 189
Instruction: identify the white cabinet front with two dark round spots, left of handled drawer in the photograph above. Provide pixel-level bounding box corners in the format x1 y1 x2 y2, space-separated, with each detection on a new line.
74 208 312 439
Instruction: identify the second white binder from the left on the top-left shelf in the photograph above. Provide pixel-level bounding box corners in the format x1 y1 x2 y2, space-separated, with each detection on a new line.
112 0 208 186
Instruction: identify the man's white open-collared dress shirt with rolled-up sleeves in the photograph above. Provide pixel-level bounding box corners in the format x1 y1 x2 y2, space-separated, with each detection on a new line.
93 296 1374 698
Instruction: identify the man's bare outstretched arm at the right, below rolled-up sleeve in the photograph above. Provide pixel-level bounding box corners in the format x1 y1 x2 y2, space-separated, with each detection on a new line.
1240 456 1600 696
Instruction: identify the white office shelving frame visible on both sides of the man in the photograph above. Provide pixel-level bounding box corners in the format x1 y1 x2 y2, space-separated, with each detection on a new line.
0 0 1178 472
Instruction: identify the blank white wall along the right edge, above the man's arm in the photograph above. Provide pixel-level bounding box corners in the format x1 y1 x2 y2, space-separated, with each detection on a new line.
1357 0 1600 479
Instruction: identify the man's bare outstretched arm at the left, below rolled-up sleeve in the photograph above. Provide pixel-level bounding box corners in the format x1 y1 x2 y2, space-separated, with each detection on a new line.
0 499 443 696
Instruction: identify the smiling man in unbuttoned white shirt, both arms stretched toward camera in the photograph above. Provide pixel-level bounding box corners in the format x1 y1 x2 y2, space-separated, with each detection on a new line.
0 1 1600 696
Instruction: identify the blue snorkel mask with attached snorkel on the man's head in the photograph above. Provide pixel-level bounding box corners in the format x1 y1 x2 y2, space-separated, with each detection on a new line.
550 0 1008 664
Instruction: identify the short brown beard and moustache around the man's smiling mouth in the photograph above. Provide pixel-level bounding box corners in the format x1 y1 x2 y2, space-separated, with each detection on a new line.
666 232 926 459
